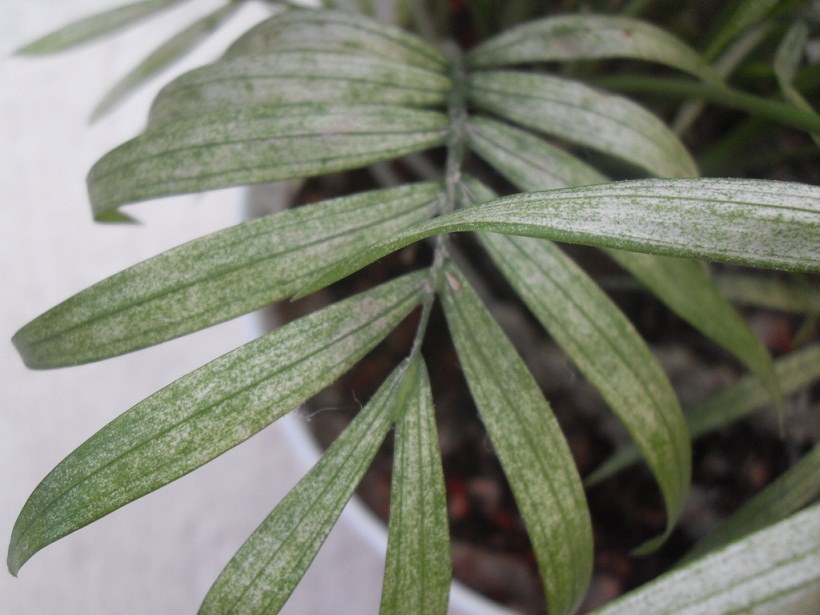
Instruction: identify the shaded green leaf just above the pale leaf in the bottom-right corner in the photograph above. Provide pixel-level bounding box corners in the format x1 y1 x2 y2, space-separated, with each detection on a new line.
679 445 820 564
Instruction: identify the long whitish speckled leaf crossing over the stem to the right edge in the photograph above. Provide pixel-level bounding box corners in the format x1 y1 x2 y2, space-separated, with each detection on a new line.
299 179 820 296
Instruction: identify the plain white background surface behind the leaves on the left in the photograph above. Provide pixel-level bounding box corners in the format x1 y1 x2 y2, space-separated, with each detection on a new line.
0 0 383 615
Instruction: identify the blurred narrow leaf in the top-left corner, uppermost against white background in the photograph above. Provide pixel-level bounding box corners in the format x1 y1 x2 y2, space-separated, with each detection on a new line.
17 0 185 55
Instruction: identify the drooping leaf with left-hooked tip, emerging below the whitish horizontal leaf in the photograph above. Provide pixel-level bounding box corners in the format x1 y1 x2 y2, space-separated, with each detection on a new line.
481 233 692 544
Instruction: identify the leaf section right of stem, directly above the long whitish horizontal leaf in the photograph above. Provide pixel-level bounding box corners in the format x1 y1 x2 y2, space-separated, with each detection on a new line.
467 115 609 190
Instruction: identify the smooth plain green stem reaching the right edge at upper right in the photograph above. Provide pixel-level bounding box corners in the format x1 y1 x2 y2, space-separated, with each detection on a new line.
596 76 820 132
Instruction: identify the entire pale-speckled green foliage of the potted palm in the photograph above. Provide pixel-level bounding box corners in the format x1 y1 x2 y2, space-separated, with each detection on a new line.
8 0 820 614
